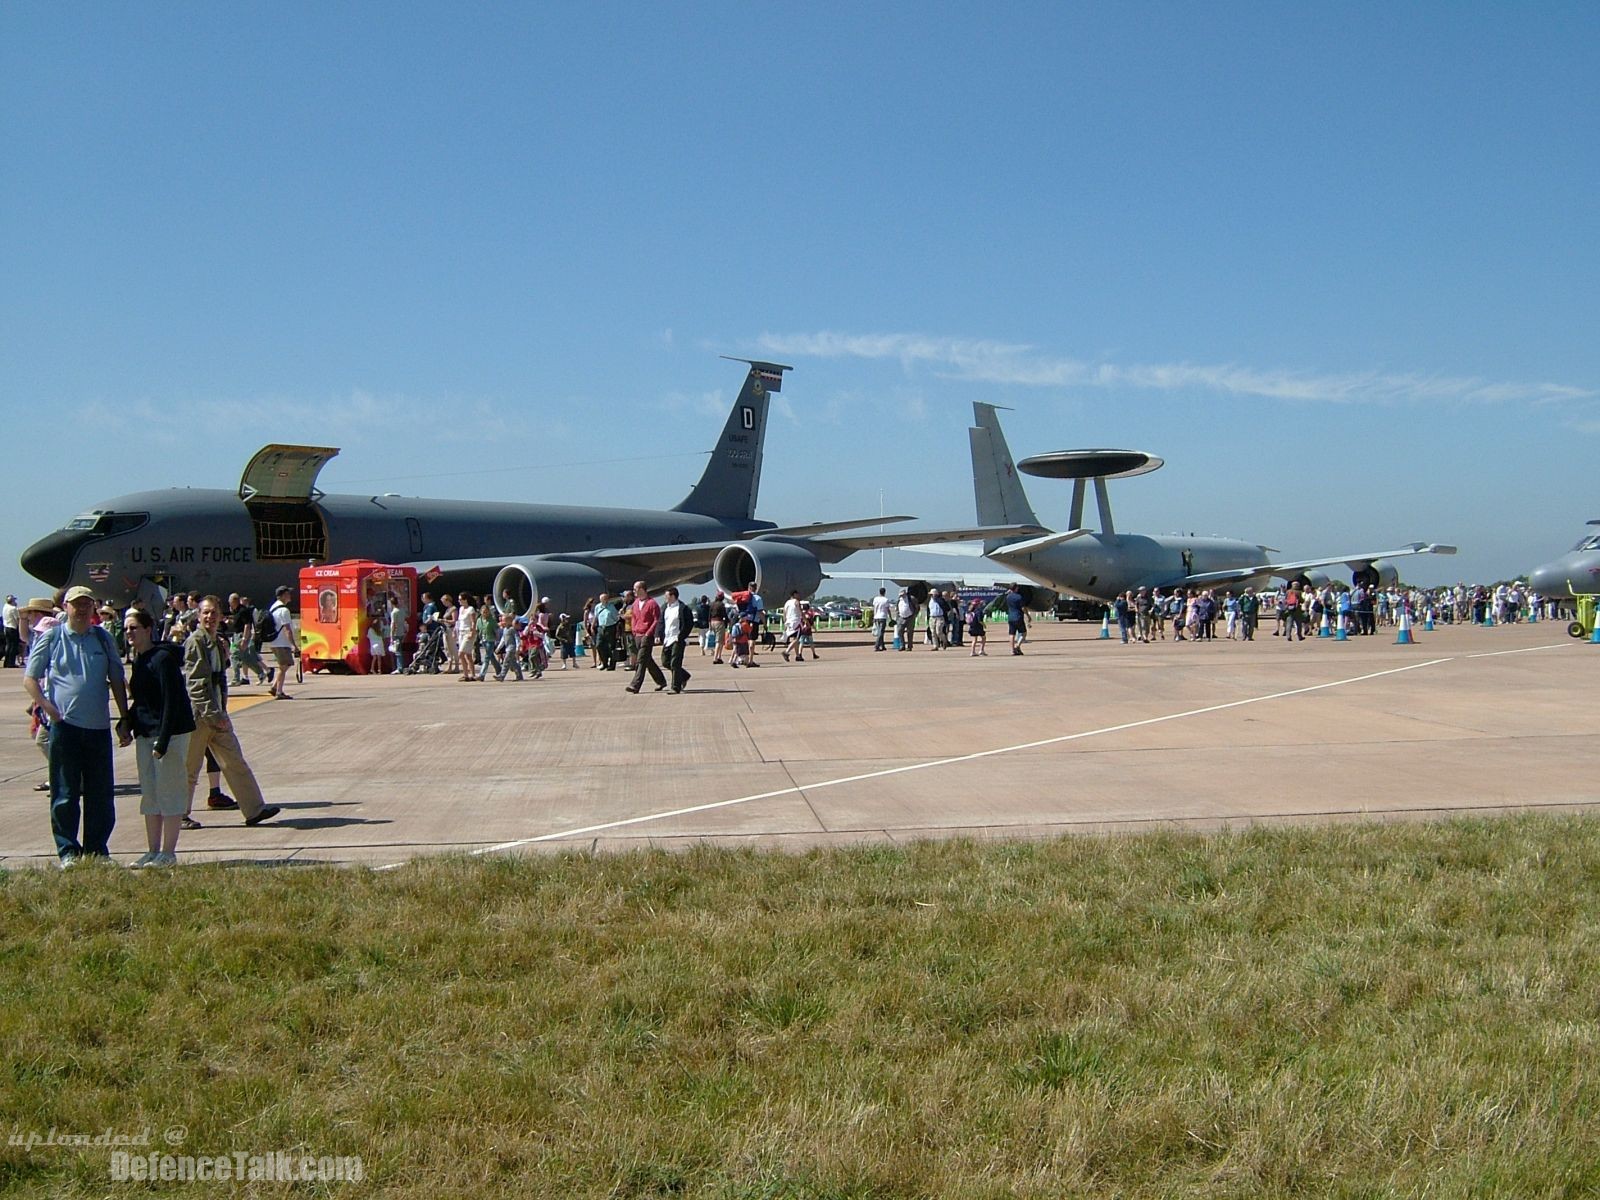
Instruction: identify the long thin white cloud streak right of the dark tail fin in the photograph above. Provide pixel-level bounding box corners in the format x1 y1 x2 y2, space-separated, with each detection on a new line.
757 331 1597 405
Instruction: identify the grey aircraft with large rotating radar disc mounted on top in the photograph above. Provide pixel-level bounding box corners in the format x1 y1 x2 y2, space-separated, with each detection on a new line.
864 403 1456 602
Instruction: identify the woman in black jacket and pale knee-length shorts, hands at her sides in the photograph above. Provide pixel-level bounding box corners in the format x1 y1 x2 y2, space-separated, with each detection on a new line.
117 608 195 867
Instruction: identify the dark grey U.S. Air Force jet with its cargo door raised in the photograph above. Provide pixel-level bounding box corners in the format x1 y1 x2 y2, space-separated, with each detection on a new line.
22 358 1037 613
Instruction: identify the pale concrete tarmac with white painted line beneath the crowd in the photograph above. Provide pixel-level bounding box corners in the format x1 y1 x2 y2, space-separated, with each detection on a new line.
0 622 1600 867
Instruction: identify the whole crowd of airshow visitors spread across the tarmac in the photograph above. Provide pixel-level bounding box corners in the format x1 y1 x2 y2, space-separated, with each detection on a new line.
3 581 1571 867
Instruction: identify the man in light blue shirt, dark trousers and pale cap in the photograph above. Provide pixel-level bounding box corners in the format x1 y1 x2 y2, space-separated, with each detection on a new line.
24 587 131 867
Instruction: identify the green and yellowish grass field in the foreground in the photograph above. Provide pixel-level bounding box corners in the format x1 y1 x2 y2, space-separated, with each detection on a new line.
0 816 1600 1197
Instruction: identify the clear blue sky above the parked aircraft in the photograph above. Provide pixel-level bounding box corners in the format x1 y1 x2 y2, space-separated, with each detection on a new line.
0 3 1600 594
